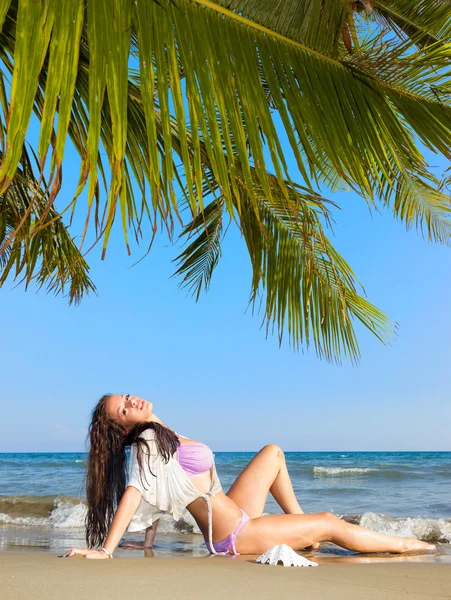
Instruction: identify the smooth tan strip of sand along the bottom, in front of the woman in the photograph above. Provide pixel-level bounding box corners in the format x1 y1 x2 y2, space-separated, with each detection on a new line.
0 552 451 600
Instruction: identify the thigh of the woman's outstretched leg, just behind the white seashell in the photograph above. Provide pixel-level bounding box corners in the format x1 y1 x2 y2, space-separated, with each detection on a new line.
235 513 331 554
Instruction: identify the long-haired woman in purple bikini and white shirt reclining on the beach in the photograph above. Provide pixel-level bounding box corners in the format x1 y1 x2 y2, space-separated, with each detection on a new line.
65 394 435 559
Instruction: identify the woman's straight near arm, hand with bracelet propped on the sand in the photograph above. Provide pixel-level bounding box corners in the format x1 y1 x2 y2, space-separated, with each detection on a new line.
64 486 142 558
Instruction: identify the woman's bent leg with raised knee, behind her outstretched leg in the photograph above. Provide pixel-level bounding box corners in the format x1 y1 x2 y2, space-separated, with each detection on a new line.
227 444 303 518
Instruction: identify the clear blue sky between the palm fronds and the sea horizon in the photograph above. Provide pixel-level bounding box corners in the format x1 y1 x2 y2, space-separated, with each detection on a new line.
0 109 451 452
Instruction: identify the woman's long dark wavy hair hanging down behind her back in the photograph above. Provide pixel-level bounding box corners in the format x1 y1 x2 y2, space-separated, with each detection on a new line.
86 394 180 548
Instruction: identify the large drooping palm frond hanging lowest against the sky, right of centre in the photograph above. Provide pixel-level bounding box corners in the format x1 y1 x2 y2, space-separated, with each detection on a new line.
240 180 393 362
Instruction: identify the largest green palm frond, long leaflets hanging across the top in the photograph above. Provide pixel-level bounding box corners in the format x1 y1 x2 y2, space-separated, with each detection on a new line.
0 0 451 247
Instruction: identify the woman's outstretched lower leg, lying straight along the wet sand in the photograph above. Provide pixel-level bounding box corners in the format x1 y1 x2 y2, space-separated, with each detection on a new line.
236 512 435 554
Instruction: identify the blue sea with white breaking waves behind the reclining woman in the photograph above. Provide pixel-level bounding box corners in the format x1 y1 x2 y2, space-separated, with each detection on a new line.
0 452 451 562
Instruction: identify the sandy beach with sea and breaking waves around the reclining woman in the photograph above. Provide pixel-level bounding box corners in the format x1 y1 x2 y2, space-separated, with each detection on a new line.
0 452 451 600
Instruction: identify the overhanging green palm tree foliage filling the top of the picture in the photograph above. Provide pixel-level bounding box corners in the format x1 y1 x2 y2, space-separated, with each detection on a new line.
0 0 451 360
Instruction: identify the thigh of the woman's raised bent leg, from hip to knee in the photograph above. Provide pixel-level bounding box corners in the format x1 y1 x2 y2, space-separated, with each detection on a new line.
227 444 283 519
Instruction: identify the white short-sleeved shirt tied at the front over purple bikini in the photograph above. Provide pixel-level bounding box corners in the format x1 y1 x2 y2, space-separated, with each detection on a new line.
128 429 222 554
